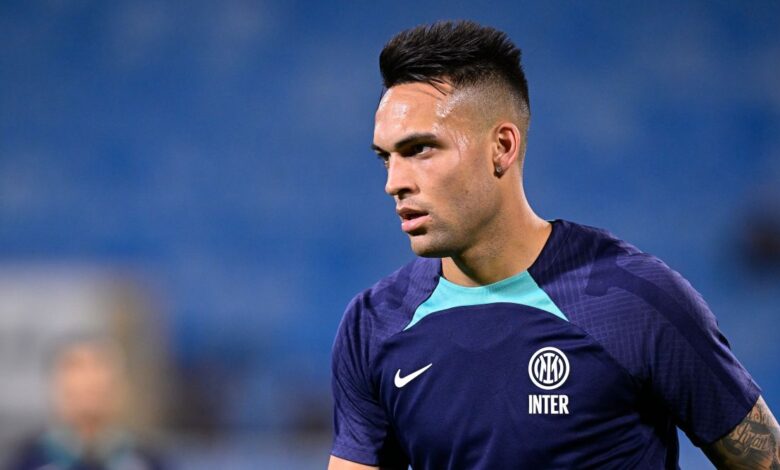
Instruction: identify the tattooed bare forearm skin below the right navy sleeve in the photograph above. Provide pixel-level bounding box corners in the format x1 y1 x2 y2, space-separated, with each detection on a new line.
700 397 780 470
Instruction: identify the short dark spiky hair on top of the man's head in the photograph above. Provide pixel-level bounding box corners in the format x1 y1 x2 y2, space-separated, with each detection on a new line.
379 20 531 119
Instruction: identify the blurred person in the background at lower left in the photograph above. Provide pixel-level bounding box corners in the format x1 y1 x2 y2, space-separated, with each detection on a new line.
7 336 163 470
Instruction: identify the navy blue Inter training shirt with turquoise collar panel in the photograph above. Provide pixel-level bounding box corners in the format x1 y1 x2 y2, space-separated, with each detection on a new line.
331 220 760 470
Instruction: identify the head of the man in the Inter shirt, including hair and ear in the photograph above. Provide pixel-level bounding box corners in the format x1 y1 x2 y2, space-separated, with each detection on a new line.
374 22 530 257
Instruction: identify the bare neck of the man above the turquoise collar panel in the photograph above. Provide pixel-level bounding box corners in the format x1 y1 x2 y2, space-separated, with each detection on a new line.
442 212 552 287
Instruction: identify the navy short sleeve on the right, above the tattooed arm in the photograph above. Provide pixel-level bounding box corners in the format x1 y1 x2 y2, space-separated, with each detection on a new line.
649 270 760 446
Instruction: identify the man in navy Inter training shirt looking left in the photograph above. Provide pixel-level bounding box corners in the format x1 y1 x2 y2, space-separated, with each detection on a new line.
329 22 780 470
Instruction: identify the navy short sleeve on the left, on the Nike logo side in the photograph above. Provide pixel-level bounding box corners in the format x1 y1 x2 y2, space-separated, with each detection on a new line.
331 298 408 467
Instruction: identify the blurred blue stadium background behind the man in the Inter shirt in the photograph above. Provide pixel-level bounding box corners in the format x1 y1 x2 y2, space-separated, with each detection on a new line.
0 0 780 470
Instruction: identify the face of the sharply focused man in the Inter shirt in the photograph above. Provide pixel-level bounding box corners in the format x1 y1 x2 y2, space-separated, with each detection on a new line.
373 83 500 257
